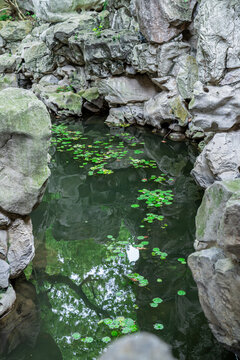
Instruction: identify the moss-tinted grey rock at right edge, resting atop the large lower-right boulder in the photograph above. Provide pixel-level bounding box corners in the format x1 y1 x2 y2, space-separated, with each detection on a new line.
195 179 240 259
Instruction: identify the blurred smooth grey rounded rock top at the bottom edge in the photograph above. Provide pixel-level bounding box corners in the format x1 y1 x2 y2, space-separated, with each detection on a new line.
100 333 174 360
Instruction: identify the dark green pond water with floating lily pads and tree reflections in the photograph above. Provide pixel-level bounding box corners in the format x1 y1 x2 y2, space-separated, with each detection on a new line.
0 117 234 360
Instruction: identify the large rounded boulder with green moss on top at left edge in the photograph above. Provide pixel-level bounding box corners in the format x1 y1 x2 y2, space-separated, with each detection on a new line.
0 88 51 215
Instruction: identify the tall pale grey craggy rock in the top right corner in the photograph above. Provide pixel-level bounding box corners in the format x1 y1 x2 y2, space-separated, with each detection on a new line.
194 0 240 84
